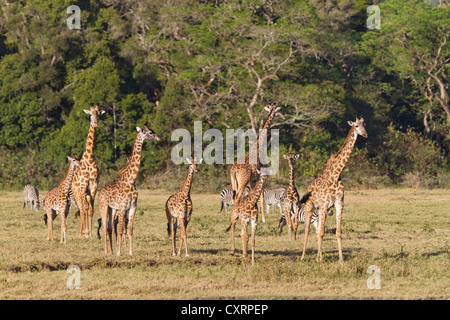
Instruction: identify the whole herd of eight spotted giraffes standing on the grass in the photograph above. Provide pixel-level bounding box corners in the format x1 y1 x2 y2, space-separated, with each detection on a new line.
24 103 367 265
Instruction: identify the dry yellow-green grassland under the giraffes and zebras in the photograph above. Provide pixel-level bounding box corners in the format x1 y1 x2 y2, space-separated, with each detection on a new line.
0 189 450 299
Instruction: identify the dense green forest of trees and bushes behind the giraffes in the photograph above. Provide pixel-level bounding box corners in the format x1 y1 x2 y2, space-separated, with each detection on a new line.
0 0 450 192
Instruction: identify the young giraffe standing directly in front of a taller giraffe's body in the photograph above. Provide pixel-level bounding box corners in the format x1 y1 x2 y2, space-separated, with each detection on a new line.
227 172 267 265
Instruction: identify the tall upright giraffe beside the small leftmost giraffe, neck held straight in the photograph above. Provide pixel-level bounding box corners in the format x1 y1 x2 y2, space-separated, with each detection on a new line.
71 103 105 238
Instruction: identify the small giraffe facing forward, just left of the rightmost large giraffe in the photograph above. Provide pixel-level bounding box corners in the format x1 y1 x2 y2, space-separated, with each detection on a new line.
281 153 300 241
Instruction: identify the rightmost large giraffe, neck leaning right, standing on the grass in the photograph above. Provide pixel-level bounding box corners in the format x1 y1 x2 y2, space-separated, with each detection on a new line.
302 117 367 265
